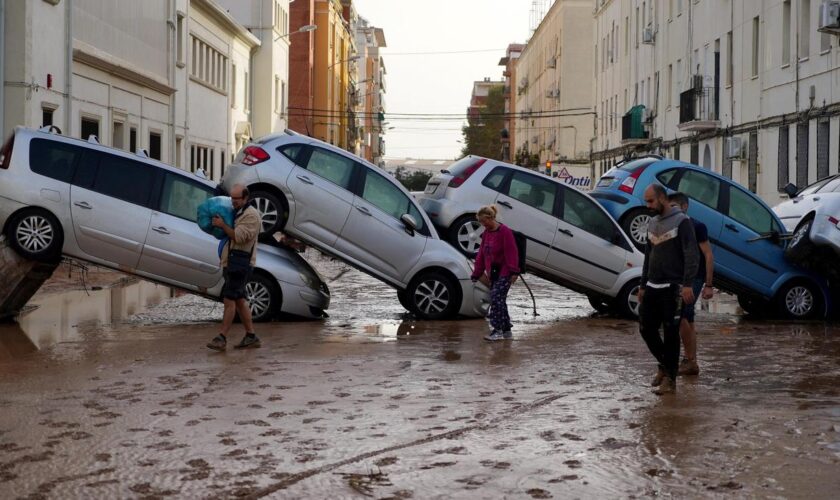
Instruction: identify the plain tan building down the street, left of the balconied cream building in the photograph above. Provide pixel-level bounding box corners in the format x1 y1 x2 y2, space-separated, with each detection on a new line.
511 0 595 187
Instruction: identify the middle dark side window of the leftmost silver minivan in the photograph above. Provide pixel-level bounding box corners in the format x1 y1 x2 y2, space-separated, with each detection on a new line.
92 155 157 206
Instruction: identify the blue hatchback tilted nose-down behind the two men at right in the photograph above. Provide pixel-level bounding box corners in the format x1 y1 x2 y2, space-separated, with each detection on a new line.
590 156 830 319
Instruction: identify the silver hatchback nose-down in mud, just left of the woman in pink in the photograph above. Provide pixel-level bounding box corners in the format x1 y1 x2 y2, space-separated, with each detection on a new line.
222 131 488 319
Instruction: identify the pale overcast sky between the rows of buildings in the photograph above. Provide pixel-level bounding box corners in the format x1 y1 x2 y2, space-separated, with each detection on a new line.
354 0 532 159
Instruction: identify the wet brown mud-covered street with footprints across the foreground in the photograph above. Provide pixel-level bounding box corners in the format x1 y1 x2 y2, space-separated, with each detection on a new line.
0 251 840 498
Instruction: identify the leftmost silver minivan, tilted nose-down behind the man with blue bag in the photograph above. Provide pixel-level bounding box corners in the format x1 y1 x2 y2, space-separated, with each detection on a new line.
0 128 330 321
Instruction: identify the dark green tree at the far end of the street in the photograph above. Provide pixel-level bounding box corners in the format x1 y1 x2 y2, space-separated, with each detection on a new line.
461 85 505 160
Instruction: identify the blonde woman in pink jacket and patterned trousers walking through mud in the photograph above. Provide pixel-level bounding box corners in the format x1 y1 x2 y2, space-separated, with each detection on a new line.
472 205 520 341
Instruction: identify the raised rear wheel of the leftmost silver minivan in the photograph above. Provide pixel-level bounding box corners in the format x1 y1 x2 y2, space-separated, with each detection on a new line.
6 209 64 262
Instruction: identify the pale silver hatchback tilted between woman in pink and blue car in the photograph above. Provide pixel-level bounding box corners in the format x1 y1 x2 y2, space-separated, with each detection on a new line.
420 156 644 316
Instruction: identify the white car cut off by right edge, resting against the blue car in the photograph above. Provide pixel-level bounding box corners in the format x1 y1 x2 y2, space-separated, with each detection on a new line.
773 174 840 274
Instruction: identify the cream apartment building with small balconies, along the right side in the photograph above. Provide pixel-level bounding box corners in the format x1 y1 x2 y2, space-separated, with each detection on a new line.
593 0 840 205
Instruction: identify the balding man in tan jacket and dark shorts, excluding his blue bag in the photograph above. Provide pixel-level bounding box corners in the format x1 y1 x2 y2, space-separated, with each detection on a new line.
207 184 261 351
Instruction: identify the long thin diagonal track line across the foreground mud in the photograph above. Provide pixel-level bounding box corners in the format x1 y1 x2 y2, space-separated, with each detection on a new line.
244 394 566 499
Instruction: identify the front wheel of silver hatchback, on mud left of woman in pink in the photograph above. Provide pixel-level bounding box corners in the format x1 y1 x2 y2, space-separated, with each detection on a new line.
407 272 461 319
